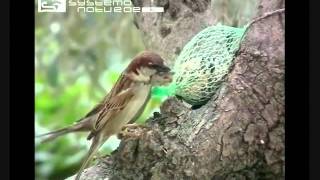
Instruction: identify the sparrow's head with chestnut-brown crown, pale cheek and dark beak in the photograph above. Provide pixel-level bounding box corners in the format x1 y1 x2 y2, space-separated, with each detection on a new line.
127 51 173 85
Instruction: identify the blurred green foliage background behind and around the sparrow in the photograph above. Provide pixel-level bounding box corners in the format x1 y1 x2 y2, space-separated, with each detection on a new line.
35 9 163 180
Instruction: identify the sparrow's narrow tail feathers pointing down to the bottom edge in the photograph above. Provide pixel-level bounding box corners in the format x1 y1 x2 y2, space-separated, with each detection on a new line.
75 134 107 180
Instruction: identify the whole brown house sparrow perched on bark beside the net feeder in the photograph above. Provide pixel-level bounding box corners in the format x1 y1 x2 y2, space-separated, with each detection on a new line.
36 51 172 180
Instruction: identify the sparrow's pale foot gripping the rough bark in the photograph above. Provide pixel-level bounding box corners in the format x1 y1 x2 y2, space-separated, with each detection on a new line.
118 123 147 140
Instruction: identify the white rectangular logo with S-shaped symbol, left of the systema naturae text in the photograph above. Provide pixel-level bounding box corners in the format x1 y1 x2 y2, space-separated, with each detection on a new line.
38 0 67 12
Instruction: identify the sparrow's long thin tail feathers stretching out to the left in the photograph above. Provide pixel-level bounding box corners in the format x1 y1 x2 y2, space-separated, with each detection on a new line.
36 121 90 143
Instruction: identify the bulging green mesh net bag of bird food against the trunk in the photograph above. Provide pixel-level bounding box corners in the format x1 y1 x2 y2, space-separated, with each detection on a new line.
152 25 246 105
